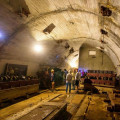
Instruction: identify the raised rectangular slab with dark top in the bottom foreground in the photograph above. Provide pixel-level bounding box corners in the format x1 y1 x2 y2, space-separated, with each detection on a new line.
18 102 67 120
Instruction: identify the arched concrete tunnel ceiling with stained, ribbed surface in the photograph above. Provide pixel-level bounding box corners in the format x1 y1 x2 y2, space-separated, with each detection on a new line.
0 0 120 66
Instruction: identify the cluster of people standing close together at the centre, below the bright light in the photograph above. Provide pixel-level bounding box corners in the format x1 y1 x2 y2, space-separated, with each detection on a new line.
66 70 81 93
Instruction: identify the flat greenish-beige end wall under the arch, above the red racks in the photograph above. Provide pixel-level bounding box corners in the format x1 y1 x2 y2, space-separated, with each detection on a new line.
79 45 116 71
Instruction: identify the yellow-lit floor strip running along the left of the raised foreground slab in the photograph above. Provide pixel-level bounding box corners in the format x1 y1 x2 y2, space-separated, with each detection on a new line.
0 93 60 120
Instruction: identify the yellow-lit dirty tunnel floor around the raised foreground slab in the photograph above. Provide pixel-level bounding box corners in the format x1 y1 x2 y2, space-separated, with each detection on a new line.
0 85 120 120
